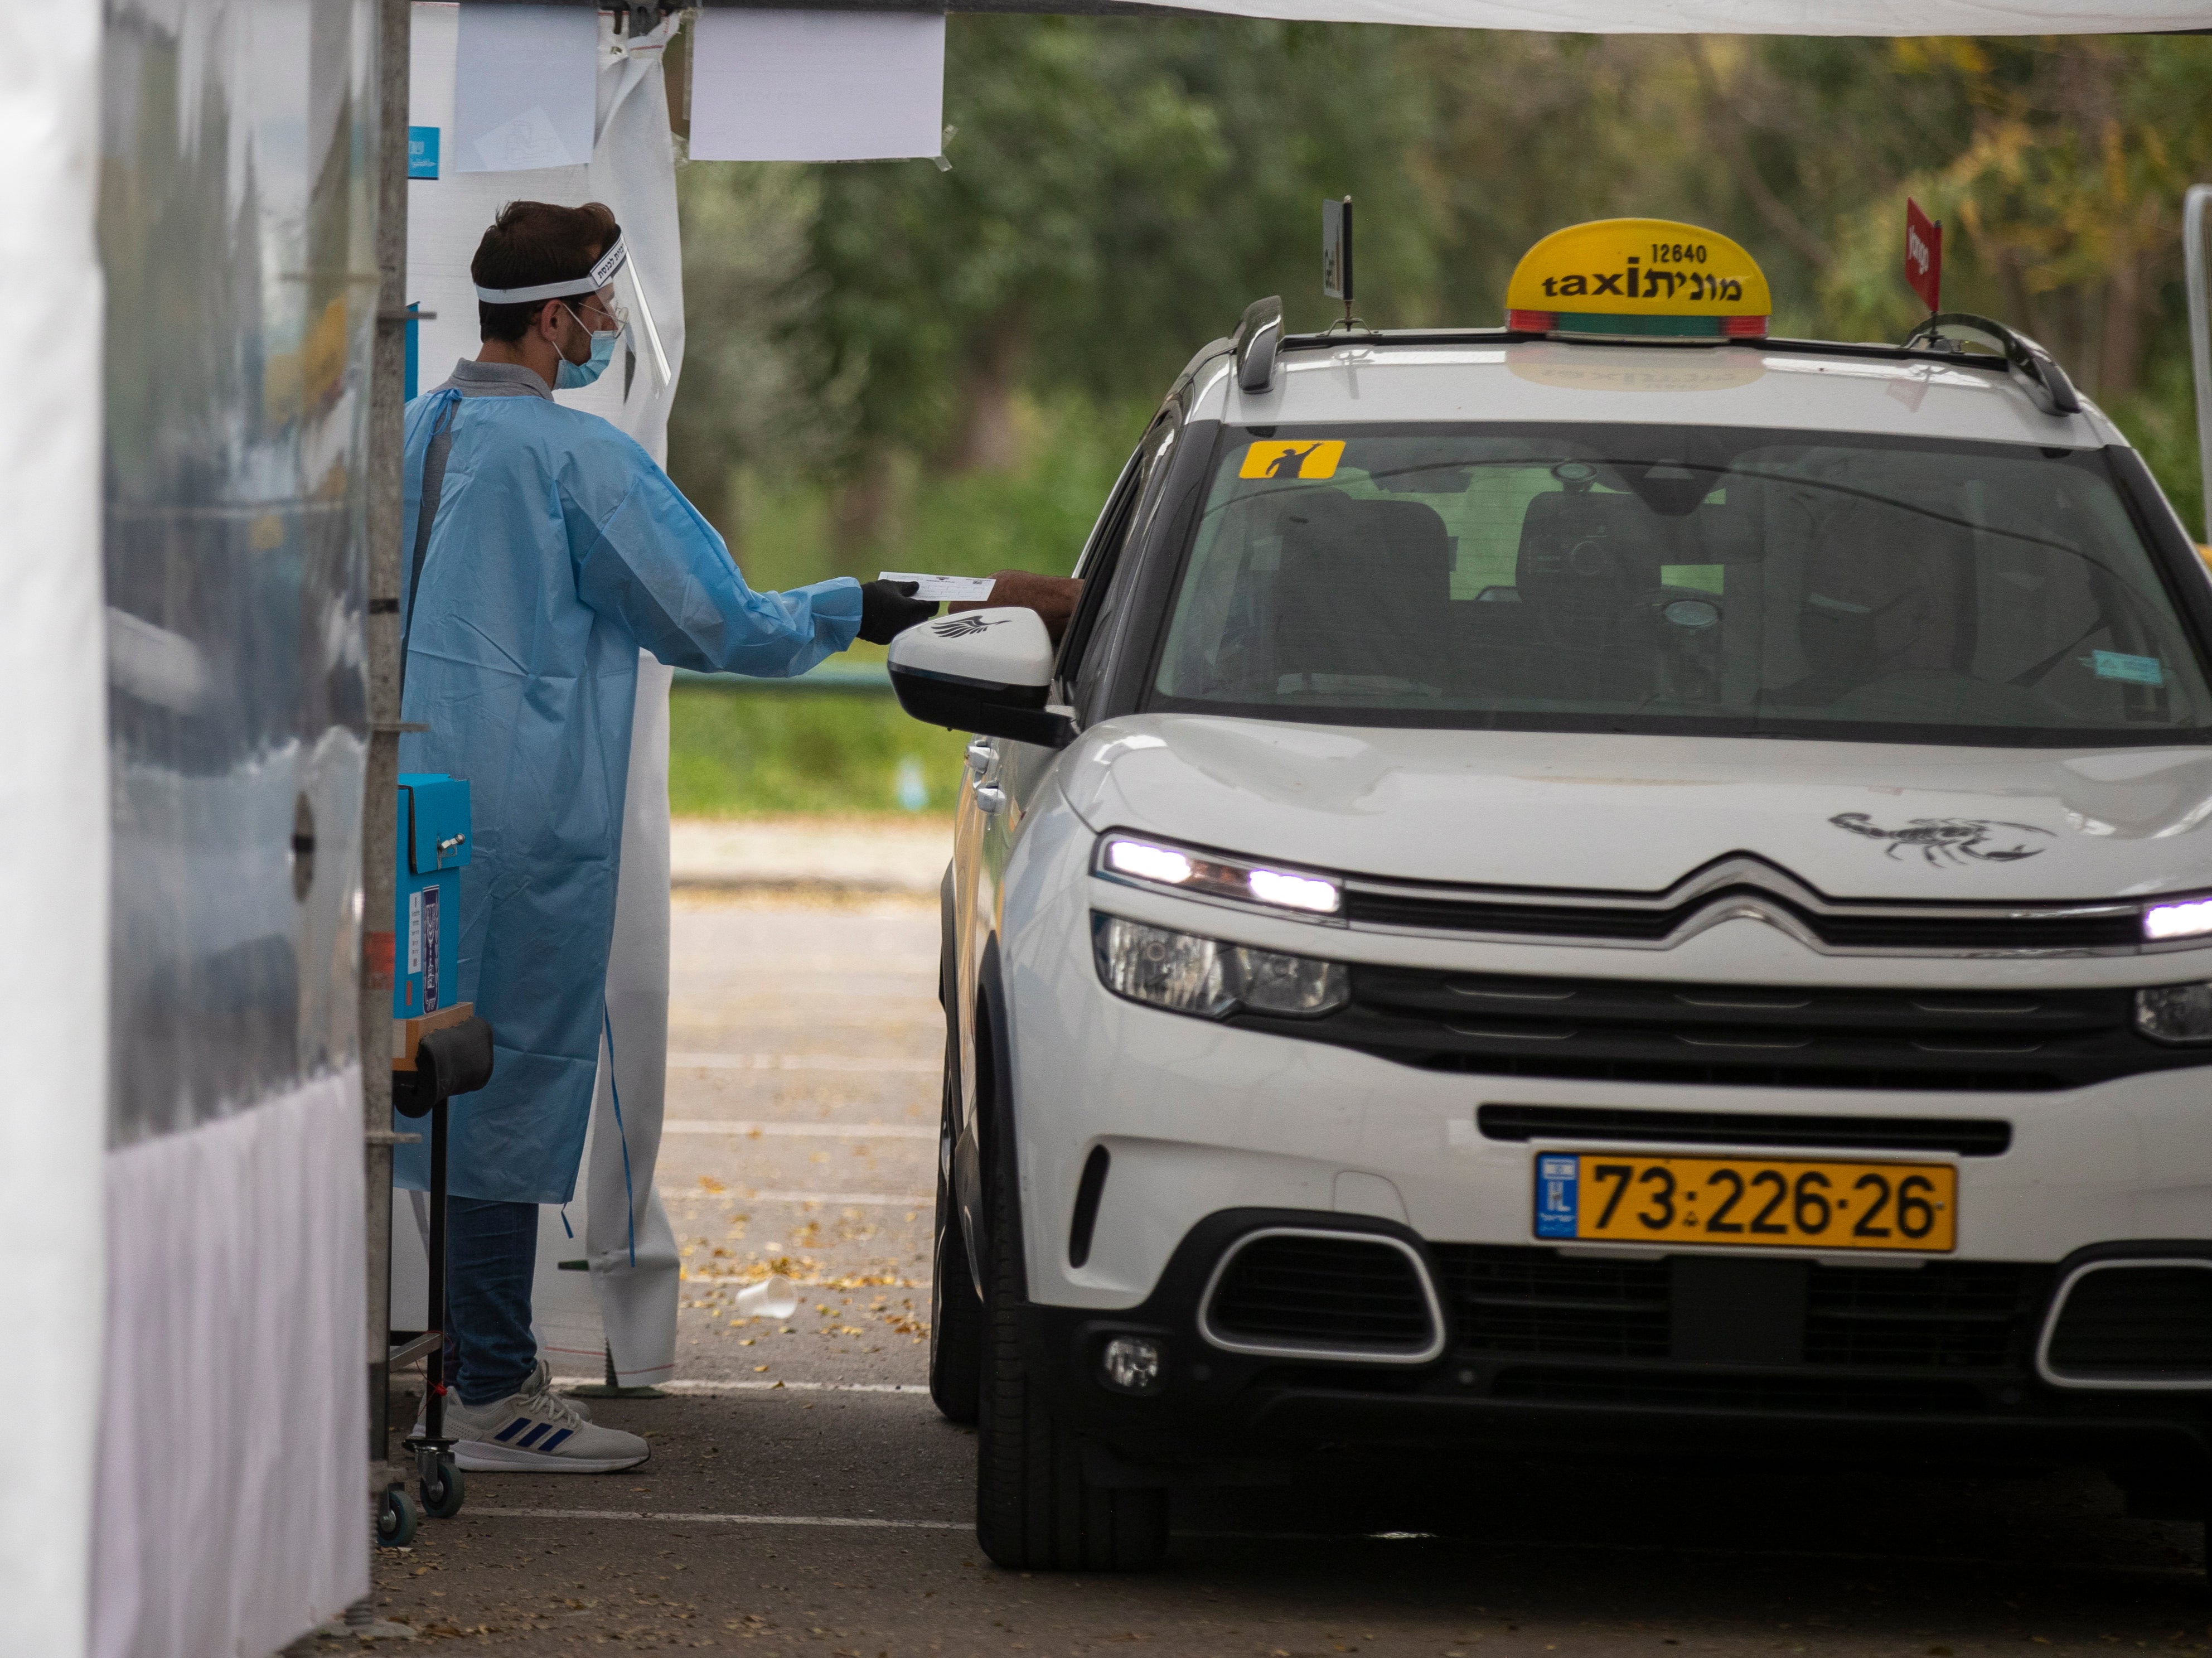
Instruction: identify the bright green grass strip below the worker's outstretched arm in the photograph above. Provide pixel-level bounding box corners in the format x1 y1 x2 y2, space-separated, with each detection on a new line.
668 686 967 817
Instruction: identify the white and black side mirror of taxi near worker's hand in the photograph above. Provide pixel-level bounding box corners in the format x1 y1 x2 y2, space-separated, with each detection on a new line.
892 607 1075 748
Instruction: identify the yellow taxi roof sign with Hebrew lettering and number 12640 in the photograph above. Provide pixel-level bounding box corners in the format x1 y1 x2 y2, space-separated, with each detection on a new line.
1507 219 1774 339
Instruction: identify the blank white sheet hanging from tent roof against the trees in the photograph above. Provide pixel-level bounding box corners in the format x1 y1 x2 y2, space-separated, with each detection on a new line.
690 7 945 162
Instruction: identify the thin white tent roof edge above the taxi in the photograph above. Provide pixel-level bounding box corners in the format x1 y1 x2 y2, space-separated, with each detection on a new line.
1159 0 2212 36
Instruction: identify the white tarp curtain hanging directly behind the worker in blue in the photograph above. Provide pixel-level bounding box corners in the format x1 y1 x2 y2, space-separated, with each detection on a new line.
391 0 684 1386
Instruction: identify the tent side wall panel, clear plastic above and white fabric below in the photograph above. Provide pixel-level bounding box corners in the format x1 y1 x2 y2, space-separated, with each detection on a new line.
93 0 376 1658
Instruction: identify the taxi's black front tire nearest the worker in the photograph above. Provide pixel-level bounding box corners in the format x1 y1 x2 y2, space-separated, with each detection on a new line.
975 1133 1168 1572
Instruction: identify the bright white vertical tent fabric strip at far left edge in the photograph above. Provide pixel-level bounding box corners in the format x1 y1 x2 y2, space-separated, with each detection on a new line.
0 7 108 1654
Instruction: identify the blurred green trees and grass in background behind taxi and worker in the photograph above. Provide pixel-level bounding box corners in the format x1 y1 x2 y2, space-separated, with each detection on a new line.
670 13 2212 810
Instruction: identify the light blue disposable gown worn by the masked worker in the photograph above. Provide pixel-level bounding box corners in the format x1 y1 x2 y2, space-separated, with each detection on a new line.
398 363 860 1204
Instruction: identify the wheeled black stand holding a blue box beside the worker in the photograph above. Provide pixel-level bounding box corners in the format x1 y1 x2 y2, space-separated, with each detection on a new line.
376 772 491 1548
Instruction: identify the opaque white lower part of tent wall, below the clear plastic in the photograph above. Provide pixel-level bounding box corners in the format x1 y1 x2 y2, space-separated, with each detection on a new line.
92 1065 369 1658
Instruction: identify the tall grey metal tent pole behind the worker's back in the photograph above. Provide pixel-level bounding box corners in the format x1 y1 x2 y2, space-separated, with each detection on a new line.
361 0 412 1485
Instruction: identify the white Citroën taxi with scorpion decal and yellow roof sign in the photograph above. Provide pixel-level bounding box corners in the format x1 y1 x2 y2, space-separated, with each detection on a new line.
892 221 2212 1569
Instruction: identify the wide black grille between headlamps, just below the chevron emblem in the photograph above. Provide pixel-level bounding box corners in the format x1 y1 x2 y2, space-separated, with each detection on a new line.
1230 963 2212 1094
